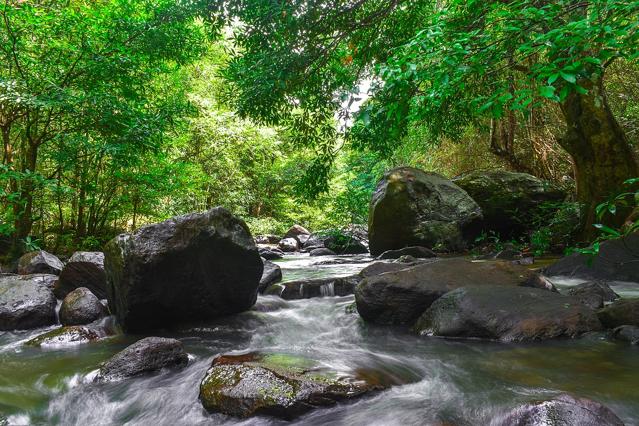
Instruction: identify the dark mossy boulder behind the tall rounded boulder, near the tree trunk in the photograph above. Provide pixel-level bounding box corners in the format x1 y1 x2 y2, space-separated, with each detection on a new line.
454 170 566 238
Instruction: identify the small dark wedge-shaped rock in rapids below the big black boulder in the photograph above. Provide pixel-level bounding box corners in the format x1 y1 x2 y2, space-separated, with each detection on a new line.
95 337 189 382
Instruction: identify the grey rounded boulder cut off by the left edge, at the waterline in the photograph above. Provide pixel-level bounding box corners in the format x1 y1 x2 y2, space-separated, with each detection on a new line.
0 275 56 331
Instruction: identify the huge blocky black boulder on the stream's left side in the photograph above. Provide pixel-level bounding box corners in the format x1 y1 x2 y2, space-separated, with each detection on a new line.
104 207 263 331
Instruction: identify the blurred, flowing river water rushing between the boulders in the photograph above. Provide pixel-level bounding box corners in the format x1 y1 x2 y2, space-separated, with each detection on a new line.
0 256 639 426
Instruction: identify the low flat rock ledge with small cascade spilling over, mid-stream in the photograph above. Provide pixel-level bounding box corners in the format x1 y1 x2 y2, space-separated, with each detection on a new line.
264 275 359 300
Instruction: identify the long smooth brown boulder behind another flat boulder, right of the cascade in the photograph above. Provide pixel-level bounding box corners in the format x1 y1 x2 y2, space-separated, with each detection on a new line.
355 258 552 325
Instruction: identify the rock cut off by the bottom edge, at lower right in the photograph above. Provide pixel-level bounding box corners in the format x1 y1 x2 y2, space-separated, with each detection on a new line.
491 395 624 426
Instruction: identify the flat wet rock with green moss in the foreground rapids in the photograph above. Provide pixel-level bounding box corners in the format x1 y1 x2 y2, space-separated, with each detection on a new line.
200 353 382 420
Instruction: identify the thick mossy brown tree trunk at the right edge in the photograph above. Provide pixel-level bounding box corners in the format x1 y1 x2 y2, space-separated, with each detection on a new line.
560 78 639 238
